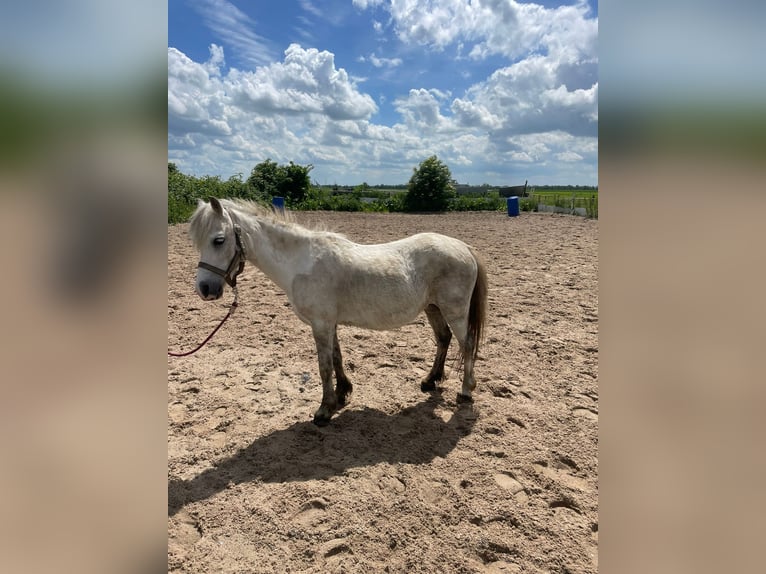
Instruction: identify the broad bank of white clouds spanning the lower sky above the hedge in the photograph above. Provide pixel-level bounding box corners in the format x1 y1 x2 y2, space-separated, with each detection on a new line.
168 33 598 183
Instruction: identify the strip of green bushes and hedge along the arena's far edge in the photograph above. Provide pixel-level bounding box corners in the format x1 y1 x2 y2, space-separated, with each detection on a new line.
168 163 598 223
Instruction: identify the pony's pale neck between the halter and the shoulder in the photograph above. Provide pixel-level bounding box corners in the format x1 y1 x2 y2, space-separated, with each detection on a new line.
243 216 310 296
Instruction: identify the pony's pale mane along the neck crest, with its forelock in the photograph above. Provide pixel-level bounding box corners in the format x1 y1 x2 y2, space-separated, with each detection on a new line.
189 198 345 248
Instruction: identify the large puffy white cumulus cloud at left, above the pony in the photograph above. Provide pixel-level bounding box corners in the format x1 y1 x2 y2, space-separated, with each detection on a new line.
168 45 388 177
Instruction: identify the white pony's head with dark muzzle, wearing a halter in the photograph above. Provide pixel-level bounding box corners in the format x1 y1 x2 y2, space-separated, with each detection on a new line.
189 197 245 301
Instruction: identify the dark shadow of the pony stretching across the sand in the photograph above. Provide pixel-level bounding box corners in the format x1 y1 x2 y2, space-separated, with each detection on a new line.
168 395 476 516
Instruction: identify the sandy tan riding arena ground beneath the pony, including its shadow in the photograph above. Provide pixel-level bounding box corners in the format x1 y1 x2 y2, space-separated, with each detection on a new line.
168 213 599 573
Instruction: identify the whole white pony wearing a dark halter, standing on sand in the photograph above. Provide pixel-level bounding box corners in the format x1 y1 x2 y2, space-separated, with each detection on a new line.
194 198 487 426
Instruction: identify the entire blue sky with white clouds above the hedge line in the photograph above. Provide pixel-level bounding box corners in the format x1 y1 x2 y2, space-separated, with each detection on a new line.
168 0 598 185
